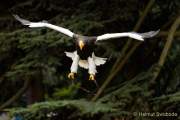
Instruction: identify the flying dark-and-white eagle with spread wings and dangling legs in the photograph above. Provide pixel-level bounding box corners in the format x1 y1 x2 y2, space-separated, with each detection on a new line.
13 15 159 80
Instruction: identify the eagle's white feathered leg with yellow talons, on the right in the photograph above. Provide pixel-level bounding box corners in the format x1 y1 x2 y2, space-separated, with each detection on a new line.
88 57 96 80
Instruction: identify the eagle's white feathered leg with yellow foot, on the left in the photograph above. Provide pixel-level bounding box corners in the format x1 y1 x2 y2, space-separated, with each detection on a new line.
68 54 79 80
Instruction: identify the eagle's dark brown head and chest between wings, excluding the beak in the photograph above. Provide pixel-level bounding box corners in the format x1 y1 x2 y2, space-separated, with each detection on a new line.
74 34 97 60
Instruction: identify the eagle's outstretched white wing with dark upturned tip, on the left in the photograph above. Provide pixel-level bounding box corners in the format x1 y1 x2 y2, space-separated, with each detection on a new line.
13 15 74 37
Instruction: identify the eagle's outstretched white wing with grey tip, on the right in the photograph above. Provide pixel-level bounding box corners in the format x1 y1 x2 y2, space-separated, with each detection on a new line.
97 30 159 41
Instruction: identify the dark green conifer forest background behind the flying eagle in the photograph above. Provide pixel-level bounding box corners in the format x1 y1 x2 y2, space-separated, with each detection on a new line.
0 0 180 120
